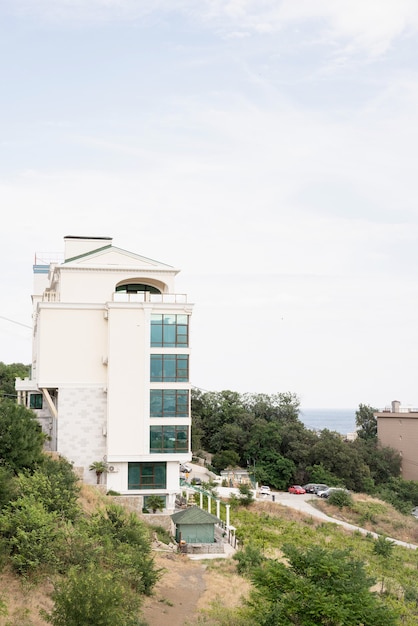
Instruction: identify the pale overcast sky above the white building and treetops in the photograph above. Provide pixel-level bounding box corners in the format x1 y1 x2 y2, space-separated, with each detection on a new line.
0 0 418 408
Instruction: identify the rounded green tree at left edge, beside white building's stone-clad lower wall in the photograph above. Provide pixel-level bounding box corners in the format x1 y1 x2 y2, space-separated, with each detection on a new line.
0 400 46 473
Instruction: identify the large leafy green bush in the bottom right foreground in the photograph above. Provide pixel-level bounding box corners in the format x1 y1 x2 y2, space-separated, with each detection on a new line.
247 545 398 626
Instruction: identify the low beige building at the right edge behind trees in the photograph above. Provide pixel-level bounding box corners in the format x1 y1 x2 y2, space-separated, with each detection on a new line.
375 400 418 480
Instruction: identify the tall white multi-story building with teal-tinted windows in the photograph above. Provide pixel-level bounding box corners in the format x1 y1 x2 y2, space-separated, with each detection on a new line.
16 236 192 510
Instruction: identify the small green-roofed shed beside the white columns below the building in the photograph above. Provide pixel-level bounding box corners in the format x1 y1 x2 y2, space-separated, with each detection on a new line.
171 506 220 543
